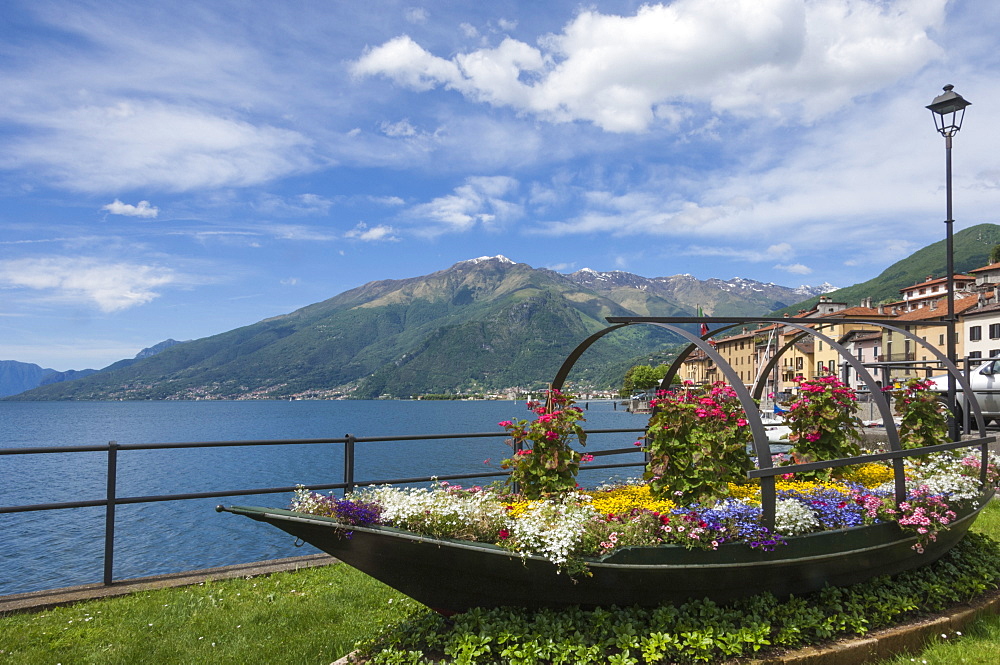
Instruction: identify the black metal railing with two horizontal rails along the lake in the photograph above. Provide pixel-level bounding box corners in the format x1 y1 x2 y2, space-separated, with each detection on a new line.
0 428 646 586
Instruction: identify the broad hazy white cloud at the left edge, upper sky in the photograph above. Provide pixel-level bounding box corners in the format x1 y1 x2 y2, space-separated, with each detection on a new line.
0 101 312 192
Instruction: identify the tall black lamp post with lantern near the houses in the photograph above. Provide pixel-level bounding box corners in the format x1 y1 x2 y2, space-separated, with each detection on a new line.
927 83 971 440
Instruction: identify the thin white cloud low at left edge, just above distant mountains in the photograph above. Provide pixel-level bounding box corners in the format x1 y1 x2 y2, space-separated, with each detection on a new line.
0 257 178 312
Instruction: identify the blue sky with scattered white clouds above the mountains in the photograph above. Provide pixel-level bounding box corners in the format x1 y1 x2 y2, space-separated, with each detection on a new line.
0 0 1000 370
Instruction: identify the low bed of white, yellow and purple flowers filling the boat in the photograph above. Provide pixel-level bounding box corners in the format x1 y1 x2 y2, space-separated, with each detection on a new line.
292 452 1000 575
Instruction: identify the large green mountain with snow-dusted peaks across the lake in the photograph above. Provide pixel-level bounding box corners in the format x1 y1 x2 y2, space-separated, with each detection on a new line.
5 256 833 400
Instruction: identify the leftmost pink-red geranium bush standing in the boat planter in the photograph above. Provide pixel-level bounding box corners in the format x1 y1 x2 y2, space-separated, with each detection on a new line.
500 390 587 499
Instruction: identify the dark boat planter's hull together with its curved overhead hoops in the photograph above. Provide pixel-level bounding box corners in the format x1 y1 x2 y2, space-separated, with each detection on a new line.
219 317 996 613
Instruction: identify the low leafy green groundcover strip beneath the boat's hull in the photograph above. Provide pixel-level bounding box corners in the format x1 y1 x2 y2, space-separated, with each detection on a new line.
359 528 1000 665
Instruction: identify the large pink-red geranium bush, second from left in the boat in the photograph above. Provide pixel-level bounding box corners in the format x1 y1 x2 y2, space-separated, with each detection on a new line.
643 383 752 505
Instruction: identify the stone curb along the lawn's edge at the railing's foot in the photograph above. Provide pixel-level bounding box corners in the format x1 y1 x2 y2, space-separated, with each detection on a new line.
0 554 338 615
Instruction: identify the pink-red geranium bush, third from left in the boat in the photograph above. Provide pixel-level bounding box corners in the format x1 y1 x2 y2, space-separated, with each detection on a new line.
785 376 861 480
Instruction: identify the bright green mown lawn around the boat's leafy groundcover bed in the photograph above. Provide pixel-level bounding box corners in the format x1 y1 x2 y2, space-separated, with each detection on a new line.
0 502 1000 665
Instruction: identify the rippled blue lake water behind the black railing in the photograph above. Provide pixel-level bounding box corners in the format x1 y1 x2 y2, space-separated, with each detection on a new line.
0 401 648 595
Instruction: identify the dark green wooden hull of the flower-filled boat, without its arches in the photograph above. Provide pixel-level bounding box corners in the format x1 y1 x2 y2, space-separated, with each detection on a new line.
219 492 992 613
